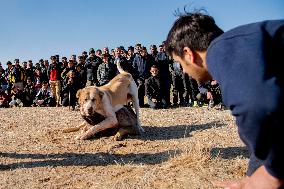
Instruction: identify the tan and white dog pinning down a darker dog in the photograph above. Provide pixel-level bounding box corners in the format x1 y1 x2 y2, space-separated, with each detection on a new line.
64 62 145 140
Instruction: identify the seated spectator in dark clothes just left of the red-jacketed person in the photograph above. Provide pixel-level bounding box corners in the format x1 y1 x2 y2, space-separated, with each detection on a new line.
33 81 55 107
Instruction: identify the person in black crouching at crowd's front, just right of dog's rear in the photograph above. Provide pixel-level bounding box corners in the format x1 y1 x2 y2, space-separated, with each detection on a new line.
145 65 167 109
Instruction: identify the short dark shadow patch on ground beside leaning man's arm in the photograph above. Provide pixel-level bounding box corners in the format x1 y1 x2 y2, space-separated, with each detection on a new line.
210 147 249 159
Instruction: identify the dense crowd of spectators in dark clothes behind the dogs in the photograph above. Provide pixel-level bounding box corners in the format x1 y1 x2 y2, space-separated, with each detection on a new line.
0 44 222 109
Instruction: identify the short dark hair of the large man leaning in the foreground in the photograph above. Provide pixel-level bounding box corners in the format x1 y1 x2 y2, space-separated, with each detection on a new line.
165 12 223 57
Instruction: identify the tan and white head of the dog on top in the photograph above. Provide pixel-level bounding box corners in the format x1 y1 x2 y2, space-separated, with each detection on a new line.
76 86 104 116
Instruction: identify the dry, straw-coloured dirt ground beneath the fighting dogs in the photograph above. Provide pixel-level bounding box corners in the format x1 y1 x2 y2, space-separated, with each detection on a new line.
0 107 248 189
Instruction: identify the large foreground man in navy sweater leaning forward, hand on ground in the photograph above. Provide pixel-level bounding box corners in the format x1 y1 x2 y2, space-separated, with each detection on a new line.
166 12 284 189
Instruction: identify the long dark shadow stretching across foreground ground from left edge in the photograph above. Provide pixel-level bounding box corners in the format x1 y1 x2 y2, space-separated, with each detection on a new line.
0 151 179 171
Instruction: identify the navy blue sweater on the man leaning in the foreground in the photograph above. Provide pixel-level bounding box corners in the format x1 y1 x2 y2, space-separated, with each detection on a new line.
206 20 284 179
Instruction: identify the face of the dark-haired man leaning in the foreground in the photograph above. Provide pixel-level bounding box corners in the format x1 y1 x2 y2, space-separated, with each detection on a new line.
173 54 211 83
